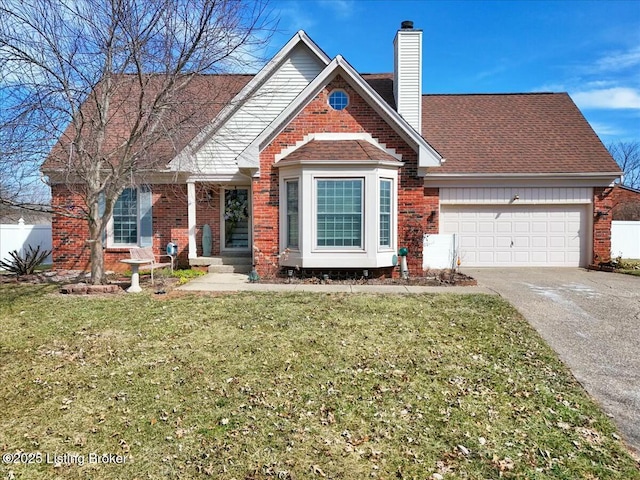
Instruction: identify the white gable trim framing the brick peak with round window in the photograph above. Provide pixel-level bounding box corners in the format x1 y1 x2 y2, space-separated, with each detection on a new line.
238 55 443 170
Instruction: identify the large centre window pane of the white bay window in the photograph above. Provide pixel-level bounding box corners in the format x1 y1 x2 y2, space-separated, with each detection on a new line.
316 179 363 248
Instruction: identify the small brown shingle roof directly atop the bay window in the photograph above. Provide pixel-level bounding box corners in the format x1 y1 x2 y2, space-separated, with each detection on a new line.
278 140 398 164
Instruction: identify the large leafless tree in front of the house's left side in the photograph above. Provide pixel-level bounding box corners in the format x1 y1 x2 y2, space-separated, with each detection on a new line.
0 0 274 283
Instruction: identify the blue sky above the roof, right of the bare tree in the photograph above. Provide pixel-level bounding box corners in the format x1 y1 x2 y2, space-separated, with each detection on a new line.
271 0 640 144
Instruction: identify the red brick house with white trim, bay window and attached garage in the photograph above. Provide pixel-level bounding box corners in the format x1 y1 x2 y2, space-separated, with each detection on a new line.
43 22 621 275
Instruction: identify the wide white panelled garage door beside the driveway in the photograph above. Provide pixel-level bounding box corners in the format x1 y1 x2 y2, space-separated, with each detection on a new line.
440 205 588 267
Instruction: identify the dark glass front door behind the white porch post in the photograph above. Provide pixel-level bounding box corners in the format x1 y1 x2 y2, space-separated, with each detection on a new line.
221 187 251 251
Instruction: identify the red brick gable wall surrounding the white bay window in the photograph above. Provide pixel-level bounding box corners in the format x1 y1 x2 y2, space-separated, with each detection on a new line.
252 77 438 275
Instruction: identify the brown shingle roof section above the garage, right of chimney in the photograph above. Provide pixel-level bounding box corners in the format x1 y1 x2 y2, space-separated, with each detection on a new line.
422 93 620 174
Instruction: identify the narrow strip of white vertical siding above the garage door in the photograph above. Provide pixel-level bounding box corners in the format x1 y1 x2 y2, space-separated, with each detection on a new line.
440 187 593 205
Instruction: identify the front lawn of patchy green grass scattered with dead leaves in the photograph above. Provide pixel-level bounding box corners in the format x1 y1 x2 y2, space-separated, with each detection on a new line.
0 284 640 480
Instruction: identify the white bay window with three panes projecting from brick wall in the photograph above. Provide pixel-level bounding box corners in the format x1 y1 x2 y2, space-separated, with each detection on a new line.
279 165 398 269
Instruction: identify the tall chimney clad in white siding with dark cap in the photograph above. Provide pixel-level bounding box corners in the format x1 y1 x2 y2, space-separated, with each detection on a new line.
393 20 422 134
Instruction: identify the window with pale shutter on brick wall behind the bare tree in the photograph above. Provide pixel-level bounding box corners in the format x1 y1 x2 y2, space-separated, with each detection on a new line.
108 185 153 247
